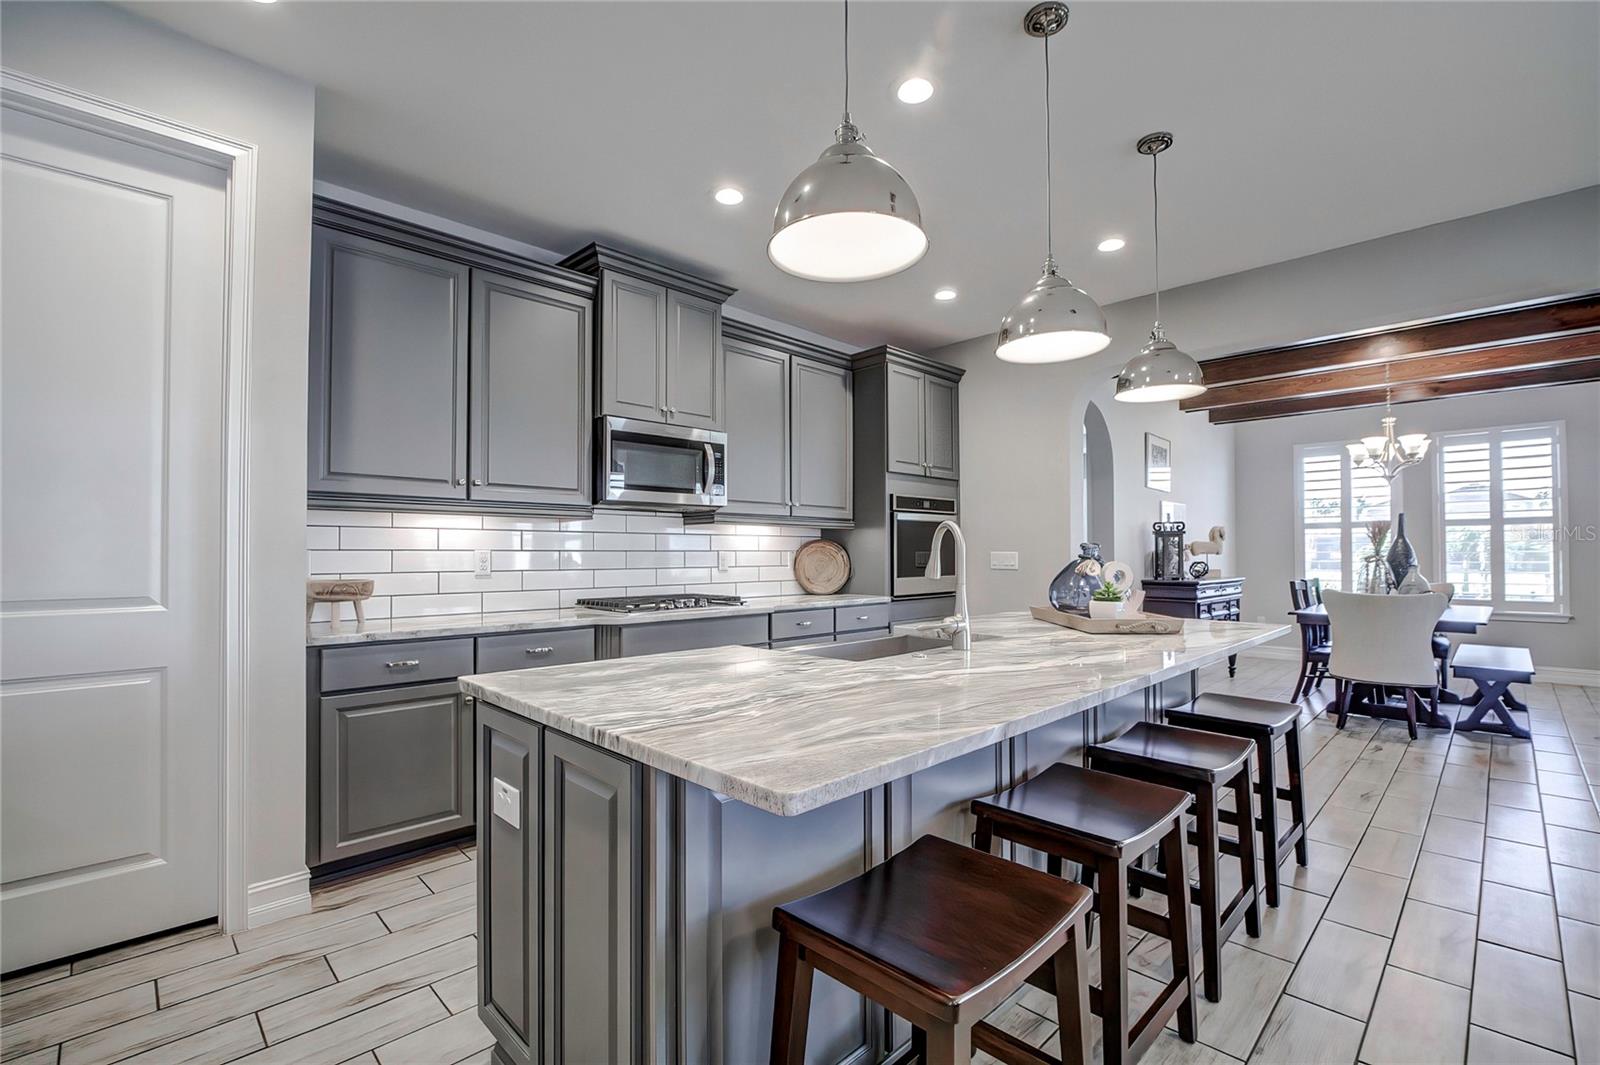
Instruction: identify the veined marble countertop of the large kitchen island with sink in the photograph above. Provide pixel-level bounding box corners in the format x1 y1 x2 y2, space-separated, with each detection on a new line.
461 612 1290 816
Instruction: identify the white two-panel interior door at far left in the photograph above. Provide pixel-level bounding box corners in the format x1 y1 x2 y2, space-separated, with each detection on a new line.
0 107 227 971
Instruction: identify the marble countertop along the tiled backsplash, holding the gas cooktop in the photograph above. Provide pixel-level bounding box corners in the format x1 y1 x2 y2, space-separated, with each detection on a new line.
306 595 890 648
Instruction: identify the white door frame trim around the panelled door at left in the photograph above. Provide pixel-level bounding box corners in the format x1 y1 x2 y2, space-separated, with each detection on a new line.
0 70 256 932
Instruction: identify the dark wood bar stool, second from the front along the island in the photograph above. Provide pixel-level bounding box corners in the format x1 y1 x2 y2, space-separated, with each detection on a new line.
973 764 1195 1065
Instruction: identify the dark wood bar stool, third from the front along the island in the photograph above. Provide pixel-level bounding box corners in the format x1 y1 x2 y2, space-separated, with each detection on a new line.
1090 721 1261 1003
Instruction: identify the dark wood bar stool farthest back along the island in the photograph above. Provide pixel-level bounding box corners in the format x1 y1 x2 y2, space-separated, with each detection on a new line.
1166 692 1307 907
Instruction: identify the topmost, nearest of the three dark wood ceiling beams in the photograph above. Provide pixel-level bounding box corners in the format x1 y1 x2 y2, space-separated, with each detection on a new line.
1202 291 1600 387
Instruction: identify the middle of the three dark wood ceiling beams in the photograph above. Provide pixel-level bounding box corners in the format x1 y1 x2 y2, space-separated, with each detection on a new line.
1181 329 1600 411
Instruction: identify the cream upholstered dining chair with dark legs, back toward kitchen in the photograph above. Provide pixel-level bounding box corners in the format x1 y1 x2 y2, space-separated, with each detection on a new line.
1323 590 1448 739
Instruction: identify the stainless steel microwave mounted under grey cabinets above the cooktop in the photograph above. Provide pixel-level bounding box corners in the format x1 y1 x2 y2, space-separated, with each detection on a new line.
595 416 728 510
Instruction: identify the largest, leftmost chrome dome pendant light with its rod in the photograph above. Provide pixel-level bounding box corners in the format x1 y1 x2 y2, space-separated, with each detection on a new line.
766 0 928 281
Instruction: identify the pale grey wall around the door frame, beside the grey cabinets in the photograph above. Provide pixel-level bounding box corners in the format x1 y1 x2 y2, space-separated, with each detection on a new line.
0 3 315 902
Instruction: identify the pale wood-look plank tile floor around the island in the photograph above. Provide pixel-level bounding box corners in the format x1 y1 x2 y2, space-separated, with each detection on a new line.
0 659 1600 1065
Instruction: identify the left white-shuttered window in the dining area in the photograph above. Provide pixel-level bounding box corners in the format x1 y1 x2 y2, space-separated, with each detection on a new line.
1294 445 1392 590
